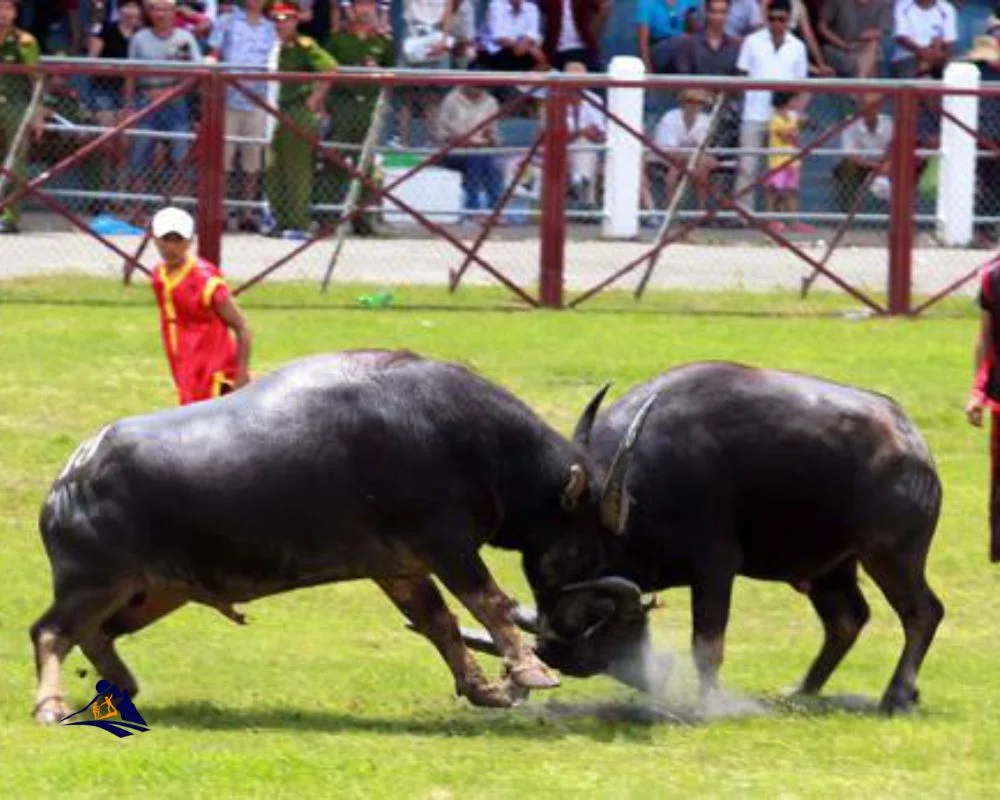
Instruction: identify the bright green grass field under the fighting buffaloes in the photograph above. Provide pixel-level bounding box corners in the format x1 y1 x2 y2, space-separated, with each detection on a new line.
0 279 1000 798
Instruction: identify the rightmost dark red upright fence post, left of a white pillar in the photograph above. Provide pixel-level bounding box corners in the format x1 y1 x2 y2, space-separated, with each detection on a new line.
888 86 917 315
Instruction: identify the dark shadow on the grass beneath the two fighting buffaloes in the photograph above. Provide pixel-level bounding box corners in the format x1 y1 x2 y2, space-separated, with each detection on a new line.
143 695 880 741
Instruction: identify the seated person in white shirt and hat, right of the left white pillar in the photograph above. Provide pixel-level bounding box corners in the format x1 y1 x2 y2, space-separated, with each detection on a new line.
643 89 717 208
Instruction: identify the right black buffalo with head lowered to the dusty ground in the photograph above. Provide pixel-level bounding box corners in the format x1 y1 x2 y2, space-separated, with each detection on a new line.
537 362 944 712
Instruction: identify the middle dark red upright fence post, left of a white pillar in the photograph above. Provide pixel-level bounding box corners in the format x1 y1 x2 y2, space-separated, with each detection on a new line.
538 84 572 308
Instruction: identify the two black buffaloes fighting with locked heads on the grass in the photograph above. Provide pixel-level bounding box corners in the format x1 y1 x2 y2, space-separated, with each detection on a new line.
31 351 943 722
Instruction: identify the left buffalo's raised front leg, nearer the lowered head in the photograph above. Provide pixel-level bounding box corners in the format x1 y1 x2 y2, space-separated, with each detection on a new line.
435 553 559 689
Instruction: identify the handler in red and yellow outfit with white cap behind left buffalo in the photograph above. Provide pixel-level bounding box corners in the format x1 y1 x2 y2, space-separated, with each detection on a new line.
152 206 252 405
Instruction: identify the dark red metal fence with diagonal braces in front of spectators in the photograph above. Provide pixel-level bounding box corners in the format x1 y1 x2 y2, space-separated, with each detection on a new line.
0 61 1000 314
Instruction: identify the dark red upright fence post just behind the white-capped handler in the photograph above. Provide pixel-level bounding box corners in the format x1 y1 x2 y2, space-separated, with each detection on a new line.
196 69 226 264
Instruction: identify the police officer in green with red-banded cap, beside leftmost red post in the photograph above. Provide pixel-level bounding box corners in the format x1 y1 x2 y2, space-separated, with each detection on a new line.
264 0 337 237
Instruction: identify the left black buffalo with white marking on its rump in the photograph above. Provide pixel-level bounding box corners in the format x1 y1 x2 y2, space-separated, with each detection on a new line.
30 351 640 722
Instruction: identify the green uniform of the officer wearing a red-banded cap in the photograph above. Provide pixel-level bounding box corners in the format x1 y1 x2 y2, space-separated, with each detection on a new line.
265 36 337 231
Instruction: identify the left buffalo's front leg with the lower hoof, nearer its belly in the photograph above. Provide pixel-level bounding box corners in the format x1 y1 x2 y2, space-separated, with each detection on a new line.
377 576 513 708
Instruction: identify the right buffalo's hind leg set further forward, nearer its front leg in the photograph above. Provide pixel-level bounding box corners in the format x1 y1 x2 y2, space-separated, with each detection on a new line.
799 559 869 694
